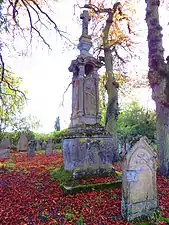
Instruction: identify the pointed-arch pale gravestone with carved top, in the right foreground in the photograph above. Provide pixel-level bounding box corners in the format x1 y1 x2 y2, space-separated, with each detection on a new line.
121 137 158 221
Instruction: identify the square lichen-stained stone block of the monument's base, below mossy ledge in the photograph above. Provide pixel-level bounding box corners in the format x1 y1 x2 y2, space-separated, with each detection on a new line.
63 136 113 176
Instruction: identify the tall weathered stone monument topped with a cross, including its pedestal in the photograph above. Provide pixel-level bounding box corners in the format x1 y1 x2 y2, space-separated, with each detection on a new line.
63 10 117 176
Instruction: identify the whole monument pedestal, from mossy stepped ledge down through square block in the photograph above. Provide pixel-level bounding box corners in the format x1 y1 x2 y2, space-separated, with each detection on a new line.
63 126 117 177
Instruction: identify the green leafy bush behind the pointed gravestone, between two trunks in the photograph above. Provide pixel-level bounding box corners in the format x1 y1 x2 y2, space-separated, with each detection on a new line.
117 101 156 145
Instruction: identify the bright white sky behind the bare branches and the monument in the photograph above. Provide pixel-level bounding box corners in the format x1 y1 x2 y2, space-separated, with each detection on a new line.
4 0 167 133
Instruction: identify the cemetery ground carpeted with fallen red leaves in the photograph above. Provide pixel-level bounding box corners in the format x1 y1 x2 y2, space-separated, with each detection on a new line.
0 152 169 225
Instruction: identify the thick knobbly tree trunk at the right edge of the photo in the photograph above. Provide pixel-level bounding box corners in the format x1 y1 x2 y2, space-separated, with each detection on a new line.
146 0 169 177
